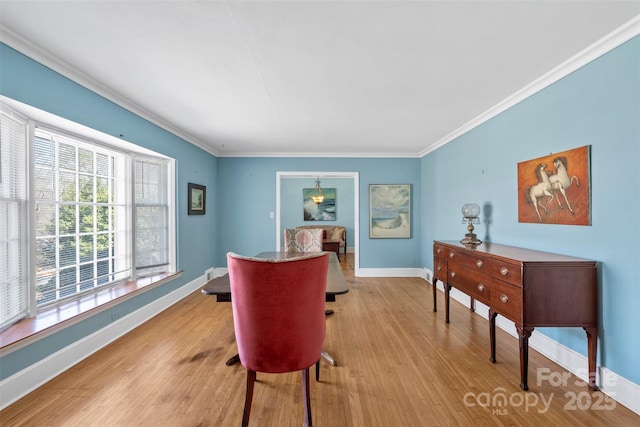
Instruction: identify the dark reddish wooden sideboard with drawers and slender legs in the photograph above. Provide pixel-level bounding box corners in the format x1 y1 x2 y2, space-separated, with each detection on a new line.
433 241 598 390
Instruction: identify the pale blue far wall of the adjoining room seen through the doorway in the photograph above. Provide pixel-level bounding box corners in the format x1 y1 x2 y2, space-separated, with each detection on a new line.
280 177 355 246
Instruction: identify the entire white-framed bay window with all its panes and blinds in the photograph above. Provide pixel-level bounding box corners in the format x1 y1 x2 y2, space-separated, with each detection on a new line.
0 101 175 327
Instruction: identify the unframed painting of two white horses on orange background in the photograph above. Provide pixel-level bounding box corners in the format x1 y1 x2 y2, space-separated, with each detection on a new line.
518 145 591 225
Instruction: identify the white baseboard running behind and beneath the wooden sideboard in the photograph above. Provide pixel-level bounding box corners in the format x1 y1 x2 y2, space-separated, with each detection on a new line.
422 271 640 415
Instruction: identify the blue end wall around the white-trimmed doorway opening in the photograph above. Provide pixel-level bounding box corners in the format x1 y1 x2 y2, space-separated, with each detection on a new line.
215 157 421 268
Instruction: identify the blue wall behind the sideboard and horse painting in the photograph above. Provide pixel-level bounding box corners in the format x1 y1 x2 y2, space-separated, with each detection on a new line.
421 37 640 384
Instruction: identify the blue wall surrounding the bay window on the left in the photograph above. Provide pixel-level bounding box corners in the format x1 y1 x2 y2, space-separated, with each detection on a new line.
0 44 218 380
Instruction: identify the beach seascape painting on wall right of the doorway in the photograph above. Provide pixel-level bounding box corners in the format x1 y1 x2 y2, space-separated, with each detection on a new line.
369 184 411 239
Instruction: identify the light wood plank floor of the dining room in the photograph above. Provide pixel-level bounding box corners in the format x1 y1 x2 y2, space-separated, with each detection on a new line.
0 254 640 427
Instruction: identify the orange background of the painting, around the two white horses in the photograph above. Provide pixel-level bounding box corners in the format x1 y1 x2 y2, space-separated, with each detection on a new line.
518 145 591 225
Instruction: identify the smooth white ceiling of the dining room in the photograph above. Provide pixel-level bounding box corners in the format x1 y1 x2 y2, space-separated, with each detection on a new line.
0 0 640 157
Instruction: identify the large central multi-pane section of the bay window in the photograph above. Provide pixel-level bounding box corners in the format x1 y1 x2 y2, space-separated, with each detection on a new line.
33 126 131 306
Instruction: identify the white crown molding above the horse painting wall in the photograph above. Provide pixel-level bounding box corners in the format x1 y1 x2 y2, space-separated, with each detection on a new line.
418 15 640 157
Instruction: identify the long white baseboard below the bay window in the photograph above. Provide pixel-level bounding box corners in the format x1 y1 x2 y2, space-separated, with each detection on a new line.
0 276 206 410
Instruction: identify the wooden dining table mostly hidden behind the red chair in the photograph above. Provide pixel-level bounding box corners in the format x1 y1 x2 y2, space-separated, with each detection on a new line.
202 251 349 366
